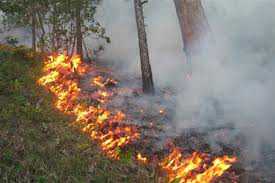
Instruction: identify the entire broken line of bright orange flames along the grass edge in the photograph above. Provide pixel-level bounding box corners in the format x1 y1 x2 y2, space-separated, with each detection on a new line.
38 54 236 183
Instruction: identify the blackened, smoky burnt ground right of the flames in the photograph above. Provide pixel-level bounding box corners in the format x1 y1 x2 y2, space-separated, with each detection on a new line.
88 57 275 183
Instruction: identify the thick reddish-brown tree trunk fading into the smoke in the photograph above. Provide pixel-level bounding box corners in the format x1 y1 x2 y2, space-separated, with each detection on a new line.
174 0 210 62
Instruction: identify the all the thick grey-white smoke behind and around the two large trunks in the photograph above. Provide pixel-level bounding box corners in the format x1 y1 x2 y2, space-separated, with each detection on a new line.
98 0 275 159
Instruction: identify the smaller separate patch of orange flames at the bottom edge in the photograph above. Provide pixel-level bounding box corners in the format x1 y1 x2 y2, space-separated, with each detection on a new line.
160 148 237 183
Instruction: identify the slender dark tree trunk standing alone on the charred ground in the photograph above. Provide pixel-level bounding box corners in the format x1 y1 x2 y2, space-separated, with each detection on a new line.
134 0 154 94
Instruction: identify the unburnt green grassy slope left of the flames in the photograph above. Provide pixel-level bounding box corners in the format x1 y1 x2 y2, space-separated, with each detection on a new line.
0 45 151 183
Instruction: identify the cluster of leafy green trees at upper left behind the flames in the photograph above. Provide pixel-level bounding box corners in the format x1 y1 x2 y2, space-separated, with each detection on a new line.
0 0 109 56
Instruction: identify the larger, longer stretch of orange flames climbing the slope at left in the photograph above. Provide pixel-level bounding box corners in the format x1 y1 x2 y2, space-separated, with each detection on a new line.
38 54 140 159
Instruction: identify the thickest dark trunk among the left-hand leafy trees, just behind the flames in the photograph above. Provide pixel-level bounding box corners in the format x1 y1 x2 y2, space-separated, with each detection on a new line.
76 2 83 60
